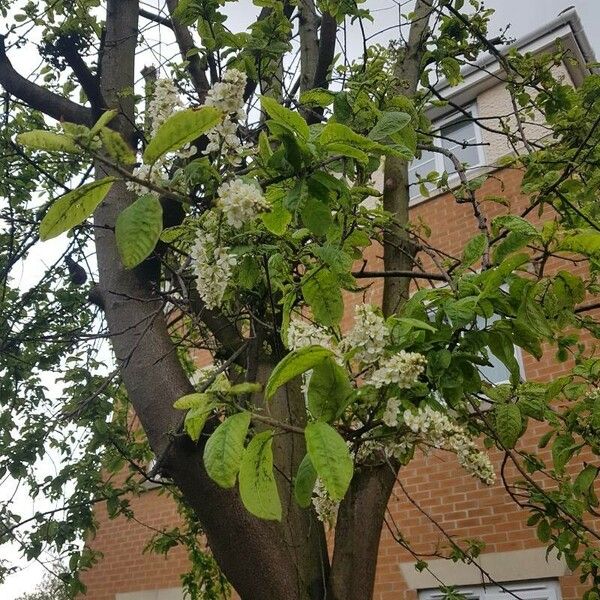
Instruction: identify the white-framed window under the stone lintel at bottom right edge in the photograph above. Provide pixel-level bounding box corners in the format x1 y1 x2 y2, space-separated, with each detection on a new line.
419 580 560 600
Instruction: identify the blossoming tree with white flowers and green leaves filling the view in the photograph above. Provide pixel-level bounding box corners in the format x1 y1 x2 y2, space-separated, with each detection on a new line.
0 0 600 600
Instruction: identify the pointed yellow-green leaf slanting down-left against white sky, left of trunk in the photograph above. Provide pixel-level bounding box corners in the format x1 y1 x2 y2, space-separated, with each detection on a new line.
40 177 115 242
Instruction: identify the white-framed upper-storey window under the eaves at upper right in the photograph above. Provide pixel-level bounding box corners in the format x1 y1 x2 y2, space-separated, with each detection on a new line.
408 107 484 198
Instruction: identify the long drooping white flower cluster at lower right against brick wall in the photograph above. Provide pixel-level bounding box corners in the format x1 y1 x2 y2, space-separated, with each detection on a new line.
404 406 496 485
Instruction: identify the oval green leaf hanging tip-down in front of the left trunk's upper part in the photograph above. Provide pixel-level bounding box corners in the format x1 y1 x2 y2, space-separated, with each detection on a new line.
115 194 162 269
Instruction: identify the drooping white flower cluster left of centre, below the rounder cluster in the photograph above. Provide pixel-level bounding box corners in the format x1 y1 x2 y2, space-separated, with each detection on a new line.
192 229 237 308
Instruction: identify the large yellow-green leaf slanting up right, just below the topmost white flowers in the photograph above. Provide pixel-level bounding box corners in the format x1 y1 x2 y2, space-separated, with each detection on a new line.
144 106 222 164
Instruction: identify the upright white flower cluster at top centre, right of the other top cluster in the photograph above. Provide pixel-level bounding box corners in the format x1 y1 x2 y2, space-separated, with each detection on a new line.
204 69 247 165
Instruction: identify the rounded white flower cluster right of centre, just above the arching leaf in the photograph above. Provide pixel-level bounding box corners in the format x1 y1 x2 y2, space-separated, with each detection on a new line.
342 304 389 363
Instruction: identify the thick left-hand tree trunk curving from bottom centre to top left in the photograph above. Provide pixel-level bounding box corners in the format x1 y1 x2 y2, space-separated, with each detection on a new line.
95 0 326 600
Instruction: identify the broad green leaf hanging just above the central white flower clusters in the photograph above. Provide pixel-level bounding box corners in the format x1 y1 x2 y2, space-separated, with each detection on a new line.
302 269 344 326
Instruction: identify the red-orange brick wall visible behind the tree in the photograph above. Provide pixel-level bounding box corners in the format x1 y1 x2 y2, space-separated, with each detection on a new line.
85 170 596 600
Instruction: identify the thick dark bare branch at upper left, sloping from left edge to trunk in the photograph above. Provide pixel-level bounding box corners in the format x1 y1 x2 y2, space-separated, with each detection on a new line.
0 35 93 125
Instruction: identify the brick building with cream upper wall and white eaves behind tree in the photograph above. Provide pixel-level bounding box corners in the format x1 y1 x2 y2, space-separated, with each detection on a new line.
85 11 593 600
